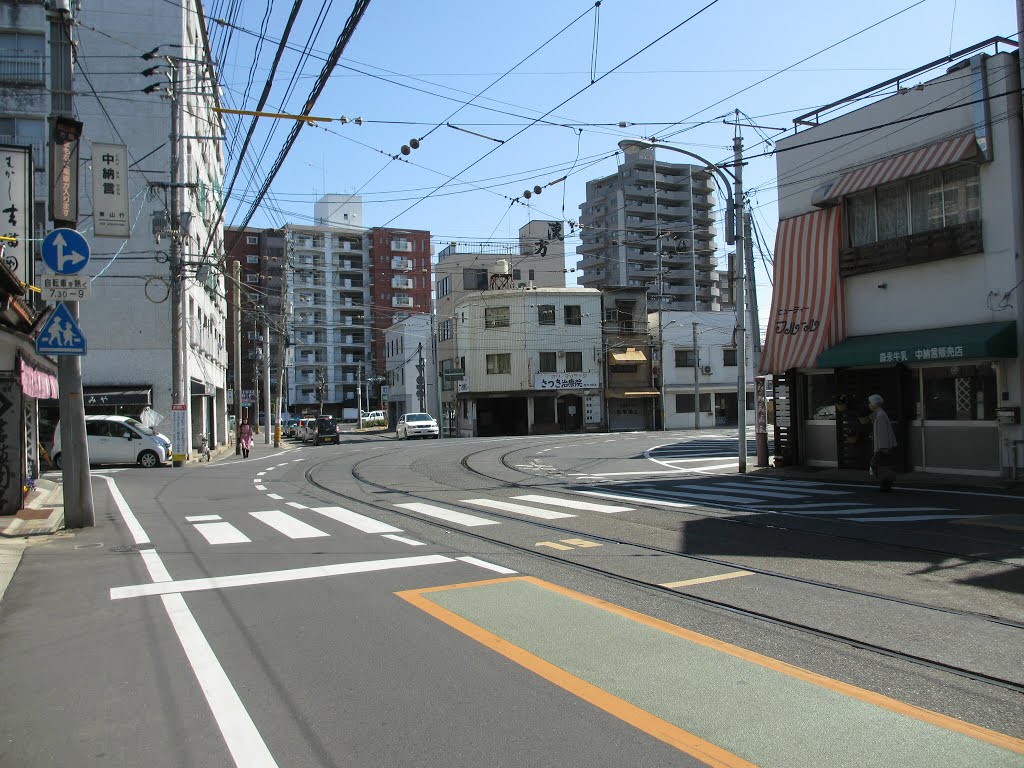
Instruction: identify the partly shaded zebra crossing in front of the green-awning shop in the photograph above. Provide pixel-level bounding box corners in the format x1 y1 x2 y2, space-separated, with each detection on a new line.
581 477 969 522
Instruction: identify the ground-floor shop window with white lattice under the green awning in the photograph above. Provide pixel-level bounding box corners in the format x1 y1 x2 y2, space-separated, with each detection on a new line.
916 365 996 421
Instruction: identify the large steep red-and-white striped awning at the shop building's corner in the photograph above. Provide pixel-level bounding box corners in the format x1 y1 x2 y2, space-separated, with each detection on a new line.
759 208 846 374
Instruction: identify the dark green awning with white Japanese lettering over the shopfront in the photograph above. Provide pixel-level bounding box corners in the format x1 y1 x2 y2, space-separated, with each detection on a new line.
817 321 1017 368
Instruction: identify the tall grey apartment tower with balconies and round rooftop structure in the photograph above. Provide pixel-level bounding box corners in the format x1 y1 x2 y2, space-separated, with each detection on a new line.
577 150 728 311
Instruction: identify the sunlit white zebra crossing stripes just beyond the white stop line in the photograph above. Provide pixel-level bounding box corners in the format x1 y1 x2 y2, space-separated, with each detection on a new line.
185 494 633 547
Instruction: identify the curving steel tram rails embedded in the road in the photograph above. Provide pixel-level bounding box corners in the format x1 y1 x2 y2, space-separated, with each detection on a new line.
304 438 1024 693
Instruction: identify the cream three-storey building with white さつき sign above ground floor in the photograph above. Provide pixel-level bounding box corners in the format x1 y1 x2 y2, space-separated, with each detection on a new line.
454 288 602 436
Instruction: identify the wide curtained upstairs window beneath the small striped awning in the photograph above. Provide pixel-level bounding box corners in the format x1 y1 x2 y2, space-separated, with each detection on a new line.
846 165 981 246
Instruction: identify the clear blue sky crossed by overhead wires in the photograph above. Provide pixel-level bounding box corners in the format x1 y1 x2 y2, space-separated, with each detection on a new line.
205 0 1017 327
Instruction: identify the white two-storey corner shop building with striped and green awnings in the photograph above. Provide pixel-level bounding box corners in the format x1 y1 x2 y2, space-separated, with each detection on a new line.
761 43 1024 476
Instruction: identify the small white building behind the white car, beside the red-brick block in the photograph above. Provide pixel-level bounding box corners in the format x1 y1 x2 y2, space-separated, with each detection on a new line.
384 314 437 424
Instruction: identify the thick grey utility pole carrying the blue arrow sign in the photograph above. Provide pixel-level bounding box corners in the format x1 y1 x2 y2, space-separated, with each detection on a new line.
49 3 96 528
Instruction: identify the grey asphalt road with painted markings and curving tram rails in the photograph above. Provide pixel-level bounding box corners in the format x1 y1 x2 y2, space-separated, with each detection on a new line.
0 432 1024 768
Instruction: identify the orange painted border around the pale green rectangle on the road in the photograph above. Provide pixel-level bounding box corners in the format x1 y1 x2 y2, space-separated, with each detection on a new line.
395 577 1024 757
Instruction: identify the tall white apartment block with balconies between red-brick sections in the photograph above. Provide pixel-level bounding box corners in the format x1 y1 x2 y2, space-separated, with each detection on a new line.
286 195 372 418
